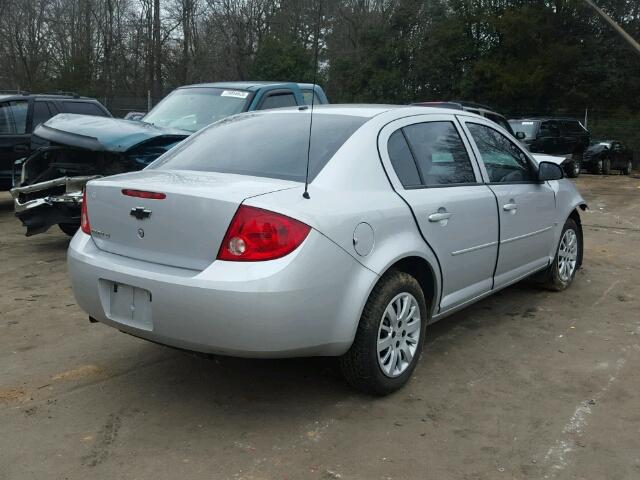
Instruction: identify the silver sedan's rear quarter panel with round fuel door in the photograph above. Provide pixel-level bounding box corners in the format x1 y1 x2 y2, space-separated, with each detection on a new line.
245 118 441 318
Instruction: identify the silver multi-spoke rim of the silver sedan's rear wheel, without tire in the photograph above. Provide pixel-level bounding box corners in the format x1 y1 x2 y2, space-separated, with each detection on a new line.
377 292 421 377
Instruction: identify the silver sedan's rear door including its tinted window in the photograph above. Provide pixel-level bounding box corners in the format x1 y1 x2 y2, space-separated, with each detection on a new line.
378 115 498 312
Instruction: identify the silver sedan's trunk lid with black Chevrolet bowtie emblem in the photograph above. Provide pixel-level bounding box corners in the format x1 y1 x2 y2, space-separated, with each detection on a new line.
87 170 299 270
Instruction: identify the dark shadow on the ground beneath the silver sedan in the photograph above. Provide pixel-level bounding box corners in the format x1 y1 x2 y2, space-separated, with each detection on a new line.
95 285 542 414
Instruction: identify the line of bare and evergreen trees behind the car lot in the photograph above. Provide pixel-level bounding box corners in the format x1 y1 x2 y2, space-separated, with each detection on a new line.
0 0 640 142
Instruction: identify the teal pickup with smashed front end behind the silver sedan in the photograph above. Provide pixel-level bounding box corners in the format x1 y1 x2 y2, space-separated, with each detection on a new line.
10 82 328 236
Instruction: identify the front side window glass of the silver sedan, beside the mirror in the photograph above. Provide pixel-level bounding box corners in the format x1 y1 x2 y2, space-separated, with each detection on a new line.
467 123 536 183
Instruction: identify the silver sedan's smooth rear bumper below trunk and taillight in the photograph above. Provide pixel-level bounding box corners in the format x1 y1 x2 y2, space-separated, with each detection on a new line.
68 230 377 357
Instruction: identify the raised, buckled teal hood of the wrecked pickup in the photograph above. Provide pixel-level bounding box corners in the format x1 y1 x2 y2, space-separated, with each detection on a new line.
34 113 193 152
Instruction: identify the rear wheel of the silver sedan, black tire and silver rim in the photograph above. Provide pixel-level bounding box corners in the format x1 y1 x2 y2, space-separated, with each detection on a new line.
340 270 428 395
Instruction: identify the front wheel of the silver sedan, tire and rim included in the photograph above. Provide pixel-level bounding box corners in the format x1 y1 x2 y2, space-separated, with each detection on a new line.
543 218 582 292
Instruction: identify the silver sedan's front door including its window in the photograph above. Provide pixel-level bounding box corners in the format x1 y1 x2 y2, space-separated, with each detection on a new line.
461 117 556 288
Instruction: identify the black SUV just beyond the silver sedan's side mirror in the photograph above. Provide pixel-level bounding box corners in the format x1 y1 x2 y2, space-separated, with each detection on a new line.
509 117 591 177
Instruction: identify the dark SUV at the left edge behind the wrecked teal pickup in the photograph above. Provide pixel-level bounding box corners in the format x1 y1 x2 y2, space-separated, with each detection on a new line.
0 92 111 191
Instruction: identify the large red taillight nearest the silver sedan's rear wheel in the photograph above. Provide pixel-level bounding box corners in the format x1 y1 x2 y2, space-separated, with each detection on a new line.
218 205 311 262
